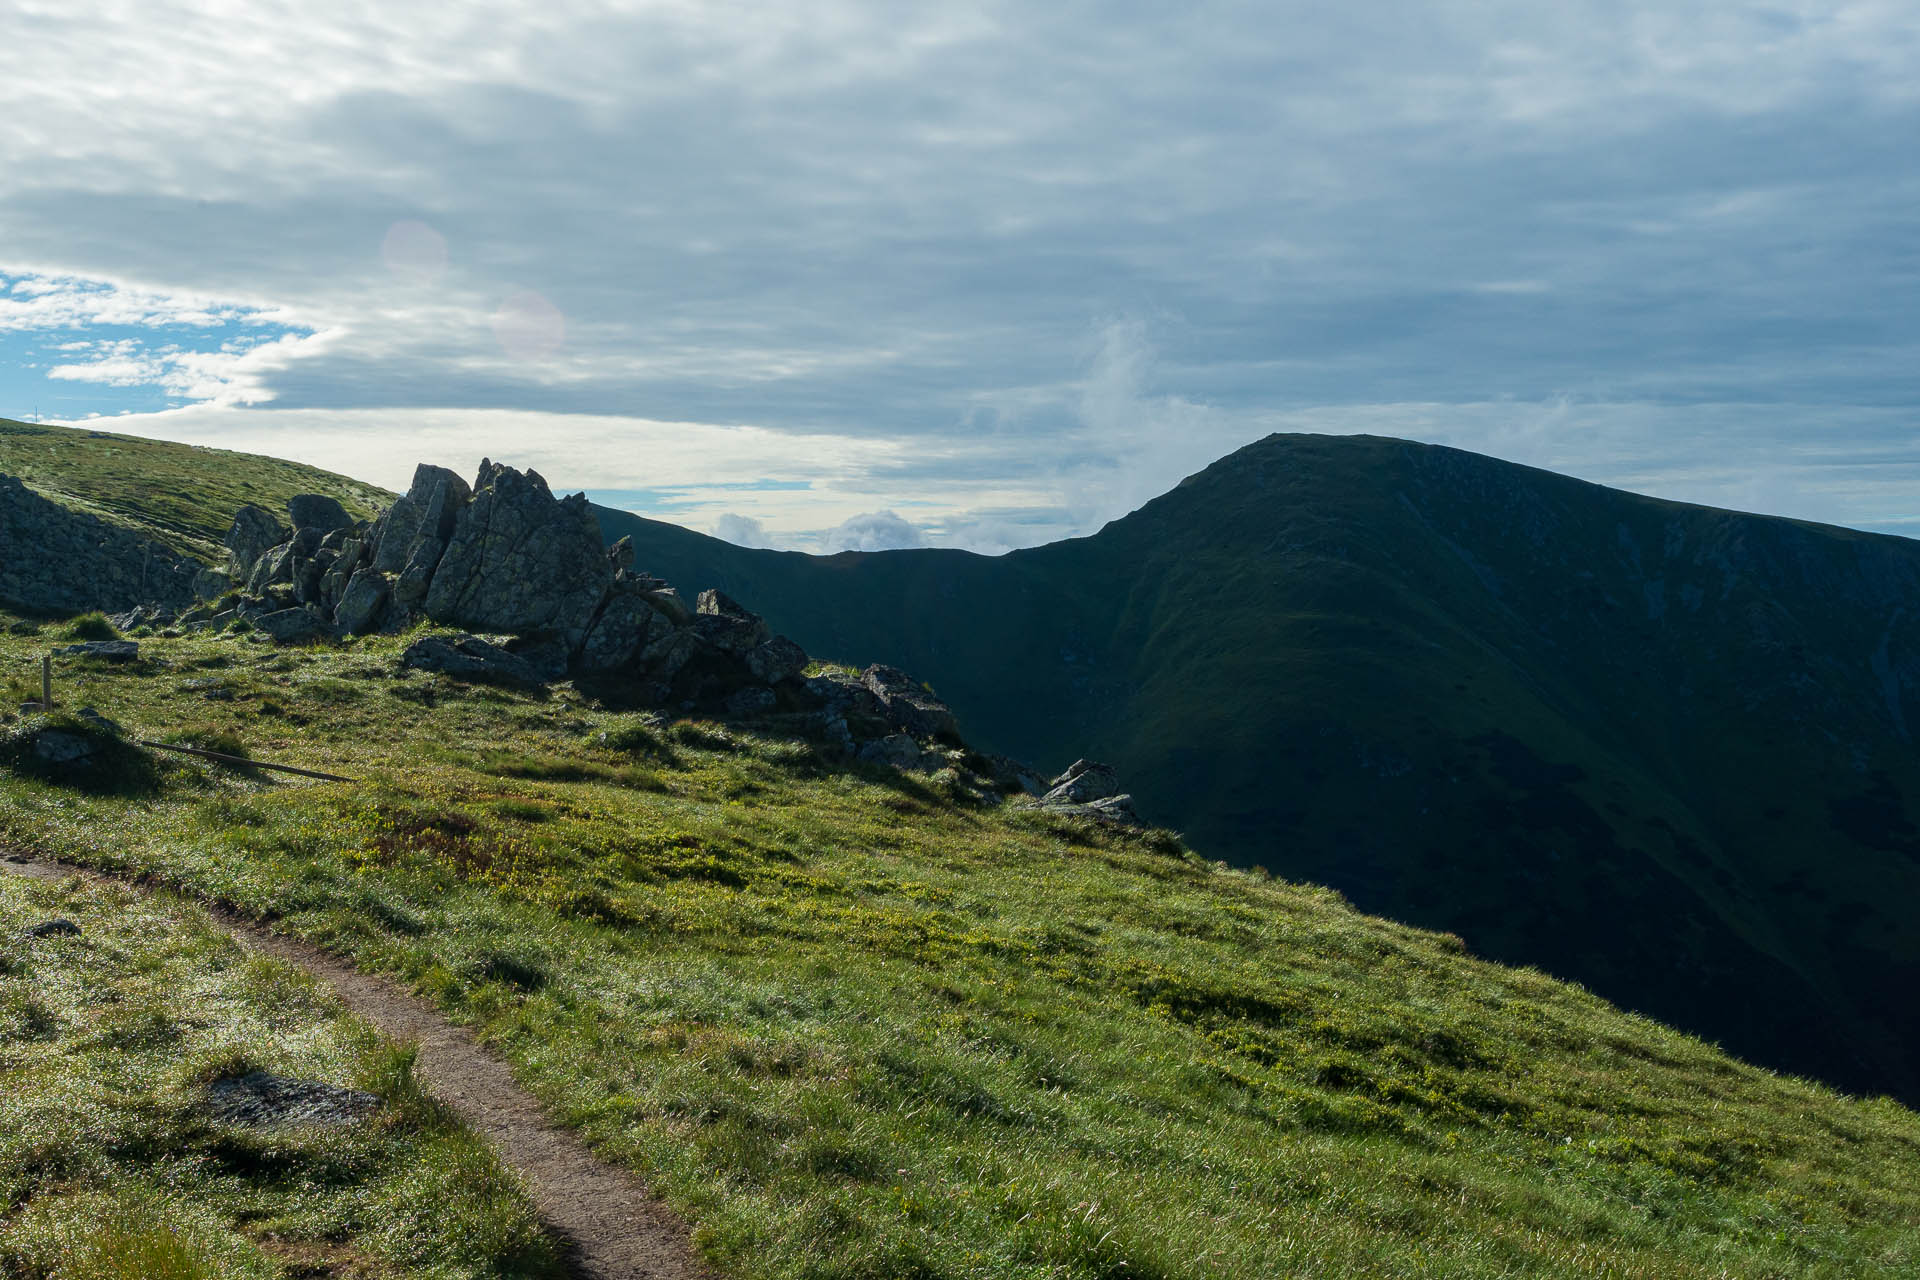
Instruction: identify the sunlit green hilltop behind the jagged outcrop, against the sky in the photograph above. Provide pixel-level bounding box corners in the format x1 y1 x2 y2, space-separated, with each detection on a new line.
0 418 394 562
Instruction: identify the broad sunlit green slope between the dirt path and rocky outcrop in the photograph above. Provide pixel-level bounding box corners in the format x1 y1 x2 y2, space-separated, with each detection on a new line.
0 617 1920 1280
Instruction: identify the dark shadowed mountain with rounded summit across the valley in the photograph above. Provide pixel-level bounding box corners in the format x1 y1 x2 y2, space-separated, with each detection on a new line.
601 436 1920 1102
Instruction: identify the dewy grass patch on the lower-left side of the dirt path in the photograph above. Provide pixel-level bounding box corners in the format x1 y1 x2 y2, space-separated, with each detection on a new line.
0 875 564 1280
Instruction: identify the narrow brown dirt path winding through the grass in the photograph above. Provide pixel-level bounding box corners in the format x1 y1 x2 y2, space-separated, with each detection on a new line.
0 850 712 1280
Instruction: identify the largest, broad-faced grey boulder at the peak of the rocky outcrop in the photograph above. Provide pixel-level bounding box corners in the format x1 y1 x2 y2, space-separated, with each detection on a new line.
422 462 612 647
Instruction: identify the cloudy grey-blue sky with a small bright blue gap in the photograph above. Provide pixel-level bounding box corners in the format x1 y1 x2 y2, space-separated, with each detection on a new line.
0 0 1920 553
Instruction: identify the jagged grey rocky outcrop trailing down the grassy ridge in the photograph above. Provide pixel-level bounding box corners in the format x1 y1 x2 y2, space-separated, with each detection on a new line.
168 462 1127 818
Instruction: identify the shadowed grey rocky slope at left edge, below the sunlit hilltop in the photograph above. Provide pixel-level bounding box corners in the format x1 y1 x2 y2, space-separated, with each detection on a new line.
0 476 207 614
